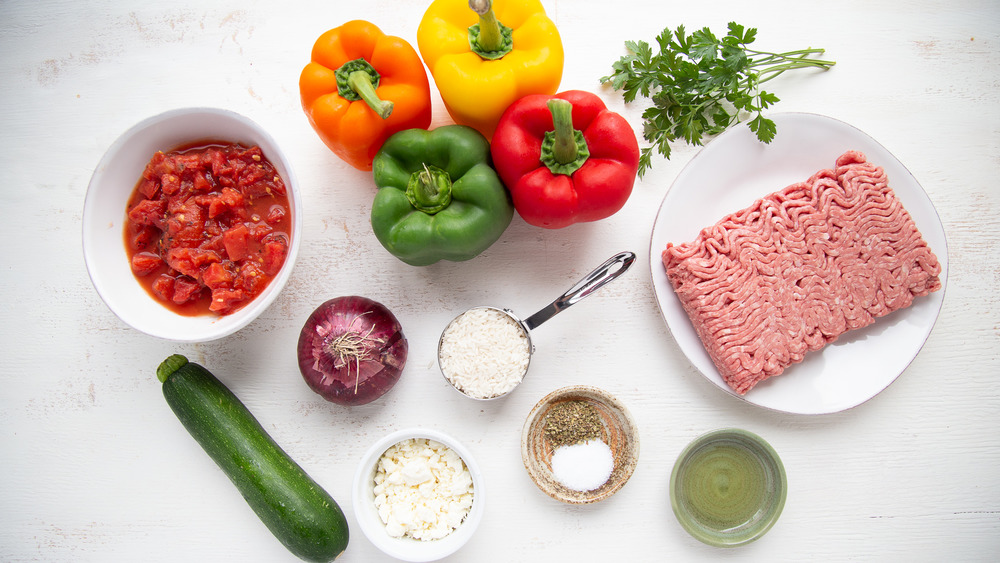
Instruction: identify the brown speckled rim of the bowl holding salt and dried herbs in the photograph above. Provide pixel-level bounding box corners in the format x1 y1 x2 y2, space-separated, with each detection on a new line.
521 385 640 504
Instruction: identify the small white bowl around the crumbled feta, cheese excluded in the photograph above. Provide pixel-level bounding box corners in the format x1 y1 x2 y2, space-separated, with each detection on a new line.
352 428 486 561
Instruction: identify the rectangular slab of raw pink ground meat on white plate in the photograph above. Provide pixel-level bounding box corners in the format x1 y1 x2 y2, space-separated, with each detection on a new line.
662 151 941 395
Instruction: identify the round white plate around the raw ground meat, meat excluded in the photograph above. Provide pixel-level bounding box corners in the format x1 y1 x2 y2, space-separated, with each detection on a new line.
649 113 948 414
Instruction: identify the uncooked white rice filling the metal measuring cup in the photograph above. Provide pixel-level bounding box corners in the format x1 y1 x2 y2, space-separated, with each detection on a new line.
438 307 531 399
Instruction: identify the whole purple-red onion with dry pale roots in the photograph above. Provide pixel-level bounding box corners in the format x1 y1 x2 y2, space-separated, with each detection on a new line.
298 296 407 405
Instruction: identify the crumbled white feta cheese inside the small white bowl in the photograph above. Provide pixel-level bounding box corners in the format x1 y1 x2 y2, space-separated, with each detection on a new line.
373 438 473 540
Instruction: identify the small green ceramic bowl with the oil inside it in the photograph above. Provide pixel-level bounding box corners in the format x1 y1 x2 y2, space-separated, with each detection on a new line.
670 428 787 547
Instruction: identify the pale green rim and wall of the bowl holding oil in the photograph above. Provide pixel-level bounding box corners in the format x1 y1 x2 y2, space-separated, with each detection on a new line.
670 427 788 547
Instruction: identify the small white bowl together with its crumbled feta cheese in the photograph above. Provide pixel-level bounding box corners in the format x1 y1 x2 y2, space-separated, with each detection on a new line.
352 428 486 562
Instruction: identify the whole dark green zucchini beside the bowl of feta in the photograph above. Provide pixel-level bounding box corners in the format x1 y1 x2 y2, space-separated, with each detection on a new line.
156 354 349 562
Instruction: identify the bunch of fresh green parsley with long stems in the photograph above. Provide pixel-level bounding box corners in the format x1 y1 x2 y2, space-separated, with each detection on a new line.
601 22 835 177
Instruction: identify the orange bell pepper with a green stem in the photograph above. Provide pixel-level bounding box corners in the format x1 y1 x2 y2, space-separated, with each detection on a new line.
299 20 431 171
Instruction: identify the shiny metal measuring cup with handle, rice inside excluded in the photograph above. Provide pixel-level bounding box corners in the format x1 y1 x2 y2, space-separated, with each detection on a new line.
438 252 635 400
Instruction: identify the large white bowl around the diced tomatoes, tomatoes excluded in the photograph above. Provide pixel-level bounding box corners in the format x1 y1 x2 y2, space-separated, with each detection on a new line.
83 108 302 342
